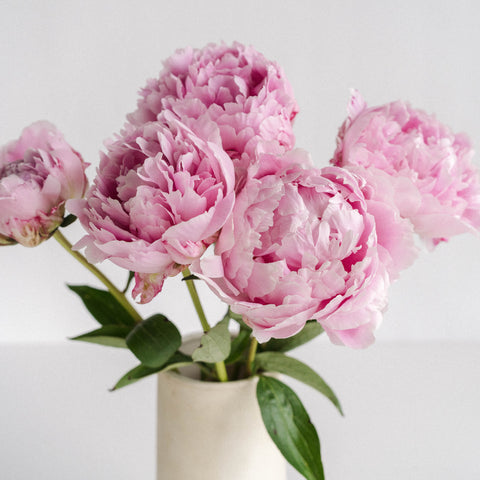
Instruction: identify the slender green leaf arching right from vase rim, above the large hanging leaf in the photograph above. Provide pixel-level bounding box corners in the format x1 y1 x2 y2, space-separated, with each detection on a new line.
255 352 343 415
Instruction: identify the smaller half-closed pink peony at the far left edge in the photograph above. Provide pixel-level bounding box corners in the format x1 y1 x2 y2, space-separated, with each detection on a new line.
0 121 88 247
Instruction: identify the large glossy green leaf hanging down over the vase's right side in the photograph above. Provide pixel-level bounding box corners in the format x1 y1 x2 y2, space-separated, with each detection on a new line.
257 376 324 480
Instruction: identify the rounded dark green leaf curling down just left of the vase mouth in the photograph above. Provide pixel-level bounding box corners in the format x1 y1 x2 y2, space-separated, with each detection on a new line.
127 314 182 368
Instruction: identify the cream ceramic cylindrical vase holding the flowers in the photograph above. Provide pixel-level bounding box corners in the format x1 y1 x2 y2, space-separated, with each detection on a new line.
157 338 287 480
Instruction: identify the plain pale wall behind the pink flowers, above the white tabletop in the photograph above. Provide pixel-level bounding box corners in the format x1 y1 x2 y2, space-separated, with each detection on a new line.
0 0 480 342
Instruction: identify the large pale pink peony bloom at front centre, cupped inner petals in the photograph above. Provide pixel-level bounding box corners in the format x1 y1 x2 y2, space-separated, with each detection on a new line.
192 158 388 348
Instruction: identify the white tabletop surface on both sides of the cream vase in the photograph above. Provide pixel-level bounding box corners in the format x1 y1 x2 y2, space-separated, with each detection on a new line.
0 340 480 480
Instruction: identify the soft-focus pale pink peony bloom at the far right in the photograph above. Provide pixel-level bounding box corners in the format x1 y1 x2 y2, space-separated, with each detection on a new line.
333 92 480 245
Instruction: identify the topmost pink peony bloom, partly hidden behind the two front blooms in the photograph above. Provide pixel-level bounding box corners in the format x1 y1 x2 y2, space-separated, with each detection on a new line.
128 43 298 188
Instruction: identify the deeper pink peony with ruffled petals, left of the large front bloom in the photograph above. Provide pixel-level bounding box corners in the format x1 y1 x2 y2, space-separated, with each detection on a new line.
69 112 234 303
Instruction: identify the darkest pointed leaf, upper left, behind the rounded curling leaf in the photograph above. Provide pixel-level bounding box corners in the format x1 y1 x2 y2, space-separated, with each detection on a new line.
68 285 135 326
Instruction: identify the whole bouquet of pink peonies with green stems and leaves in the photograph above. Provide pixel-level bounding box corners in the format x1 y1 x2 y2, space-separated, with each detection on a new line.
0 43 480 479
